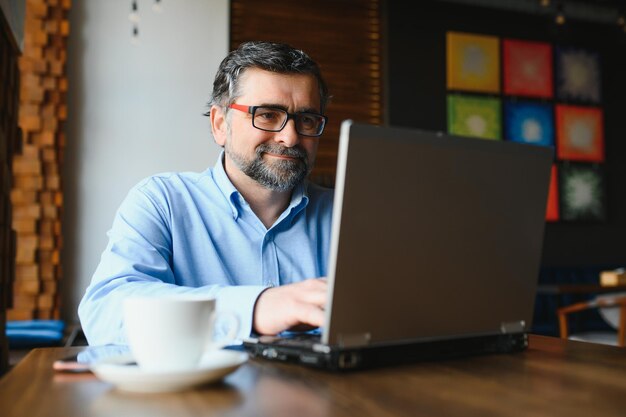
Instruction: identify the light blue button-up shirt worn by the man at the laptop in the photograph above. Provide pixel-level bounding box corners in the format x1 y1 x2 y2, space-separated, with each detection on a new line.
78 153 333 345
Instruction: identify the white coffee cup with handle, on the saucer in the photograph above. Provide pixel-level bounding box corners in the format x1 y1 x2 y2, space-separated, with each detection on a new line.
124 295 239 372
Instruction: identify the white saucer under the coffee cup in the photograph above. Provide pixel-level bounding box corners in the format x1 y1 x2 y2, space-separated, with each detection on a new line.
91 350 248 392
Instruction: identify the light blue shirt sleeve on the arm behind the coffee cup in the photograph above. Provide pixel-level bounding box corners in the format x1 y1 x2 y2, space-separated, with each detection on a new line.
78 183 266 345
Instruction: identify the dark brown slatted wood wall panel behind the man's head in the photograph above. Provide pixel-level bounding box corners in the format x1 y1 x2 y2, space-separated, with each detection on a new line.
230 0 384 186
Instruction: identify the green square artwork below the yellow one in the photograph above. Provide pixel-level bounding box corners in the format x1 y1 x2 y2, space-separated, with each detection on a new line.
448 94 502 139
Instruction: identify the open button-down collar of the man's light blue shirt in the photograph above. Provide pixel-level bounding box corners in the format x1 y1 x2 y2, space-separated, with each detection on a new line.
213 150 309 220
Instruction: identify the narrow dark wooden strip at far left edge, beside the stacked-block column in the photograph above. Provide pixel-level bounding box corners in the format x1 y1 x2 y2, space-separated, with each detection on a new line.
0 5 20 375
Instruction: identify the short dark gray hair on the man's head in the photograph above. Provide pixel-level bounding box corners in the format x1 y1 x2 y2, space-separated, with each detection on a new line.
207 42 330 116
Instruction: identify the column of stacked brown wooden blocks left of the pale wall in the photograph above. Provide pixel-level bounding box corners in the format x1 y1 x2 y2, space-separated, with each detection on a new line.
7 0 70 320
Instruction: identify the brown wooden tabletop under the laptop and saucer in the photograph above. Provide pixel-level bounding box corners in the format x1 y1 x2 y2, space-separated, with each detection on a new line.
0 336 626 417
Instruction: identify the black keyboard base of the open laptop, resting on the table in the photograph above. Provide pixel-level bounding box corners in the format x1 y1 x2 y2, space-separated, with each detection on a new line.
244 333 528 371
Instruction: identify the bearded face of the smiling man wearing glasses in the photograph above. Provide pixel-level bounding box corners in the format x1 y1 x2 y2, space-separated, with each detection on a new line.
218 69 320 191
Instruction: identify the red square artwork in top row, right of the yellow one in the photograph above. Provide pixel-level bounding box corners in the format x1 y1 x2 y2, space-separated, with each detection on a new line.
502 39 554 98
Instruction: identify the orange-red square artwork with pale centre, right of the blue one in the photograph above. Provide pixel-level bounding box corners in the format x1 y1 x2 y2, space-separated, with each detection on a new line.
555 104 604 162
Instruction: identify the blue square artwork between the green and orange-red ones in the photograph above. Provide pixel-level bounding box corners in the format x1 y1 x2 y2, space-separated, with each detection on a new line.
504 101 554 146
